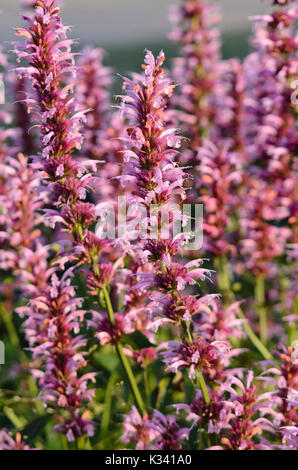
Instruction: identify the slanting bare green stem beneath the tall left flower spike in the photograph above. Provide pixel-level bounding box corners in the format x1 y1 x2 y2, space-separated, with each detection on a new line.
103 287 146 415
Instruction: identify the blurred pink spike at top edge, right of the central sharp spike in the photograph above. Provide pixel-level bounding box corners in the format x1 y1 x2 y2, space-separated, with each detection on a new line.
171 0 220 156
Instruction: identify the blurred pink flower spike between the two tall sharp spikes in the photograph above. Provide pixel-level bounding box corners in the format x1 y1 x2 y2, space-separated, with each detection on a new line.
76 46 124 202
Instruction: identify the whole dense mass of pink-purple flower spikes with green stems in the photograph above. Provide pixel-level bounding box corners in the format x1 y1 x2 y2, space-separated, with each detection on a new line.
0 0 298 450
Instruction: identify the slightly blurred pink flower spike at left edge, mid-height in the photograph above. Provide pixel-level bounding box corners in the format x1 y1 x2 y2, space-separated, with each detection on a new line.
0 154 53 296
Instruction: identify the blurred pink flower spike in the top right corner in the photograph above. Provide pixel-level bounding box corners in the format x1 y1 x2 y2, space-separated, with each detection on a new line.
244 2 298 242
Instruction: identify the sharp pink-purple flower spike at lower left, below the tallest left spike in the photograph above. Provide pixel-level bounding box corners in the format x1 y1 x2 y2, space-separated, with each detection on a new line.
18 274 96 441
